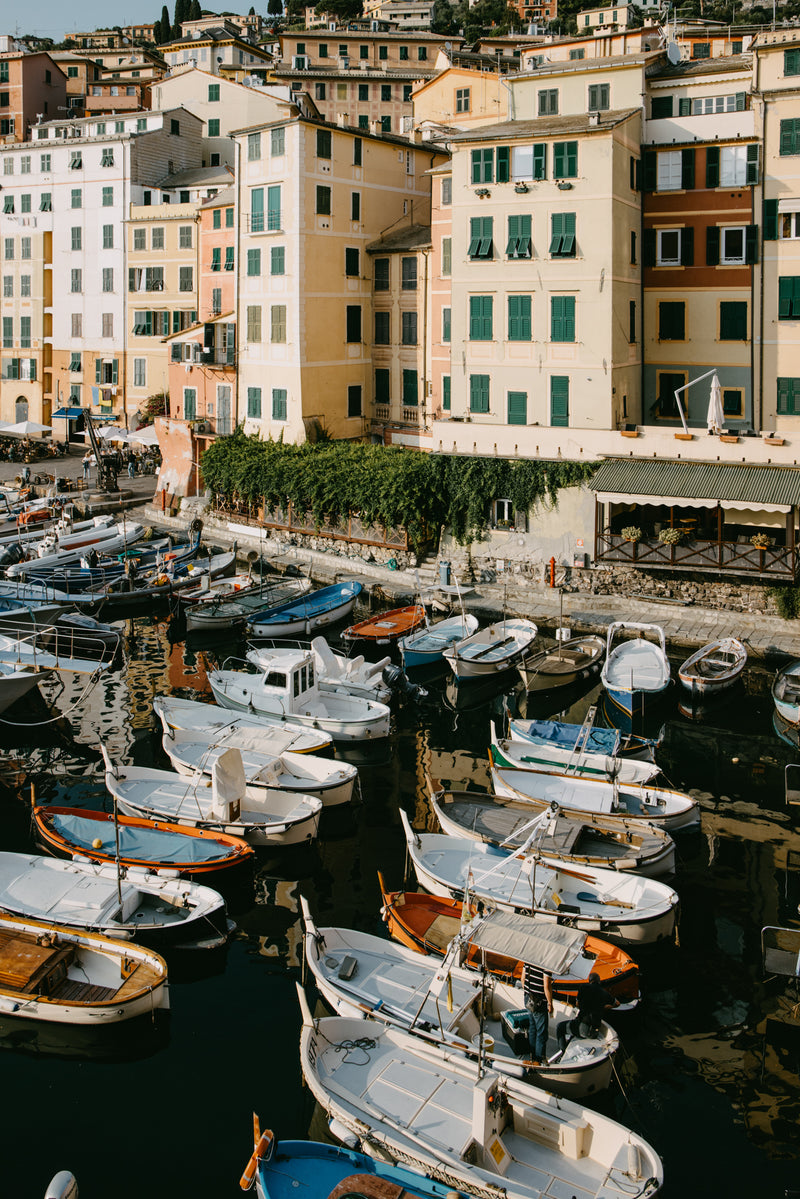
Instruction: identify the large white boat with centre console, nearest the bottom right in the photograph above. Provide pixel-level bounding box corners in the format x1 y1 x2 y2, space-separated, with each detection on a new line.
299 988 663 1199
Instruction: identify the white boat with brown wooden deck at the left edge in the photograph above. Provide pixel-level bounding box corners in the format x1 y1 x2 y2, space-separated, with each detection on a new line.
0 915 169 1025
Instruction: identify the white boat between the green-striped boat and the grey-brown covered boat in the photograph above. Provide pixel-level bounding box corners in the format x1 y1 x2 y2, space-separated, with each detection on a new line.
489 746 700 833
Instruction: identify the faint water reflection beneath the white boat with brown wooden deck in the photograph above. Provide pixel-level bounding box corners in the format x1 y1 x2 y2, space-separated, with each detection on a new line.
0 1011 170 1062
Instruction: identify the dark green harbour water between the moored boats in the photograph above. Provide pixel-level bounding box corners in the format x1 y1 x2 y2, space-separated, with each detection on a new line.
0 619 800 1199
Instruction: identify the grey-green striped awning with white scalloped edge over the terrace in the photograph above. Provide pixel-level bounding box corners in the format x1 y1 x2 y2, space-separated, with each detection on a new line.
589 458 800 512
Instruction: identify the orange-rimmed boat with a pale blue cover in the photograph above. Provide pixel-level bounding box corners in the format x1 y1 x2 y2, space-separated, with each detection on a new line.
32 806 254 884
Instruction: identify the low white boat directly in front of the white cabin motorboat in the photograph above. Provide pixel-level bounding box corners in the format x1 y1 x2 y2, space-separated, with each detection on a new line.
152 695 333 755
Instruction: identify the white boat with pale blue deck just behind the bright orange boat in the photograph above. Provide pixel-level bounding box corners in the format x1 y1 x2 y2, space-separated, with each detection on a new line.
401 808 678 946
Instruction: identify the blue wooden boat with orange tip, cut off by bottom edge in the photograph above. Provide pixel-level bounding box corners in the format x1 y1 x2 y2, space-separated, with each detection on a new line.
240 1117 465 1199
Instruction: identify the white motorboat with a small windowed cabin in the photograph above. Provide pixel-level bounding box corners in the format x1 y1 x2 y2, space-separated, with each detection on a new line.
207 649 391 741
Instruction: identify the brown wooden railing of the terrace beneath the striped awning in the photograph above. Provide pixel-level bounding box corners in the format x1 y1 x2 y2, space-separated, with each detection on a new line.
595 529 798 579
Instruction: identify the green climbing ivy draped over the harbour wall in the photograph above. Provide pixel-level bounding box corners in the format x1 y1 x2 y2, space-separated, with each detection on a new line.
201 429 595 550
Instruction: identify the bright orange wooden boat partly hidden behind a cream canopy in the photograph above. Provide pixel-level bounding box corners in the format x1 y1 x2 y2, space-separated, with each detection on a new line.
378 872 639 1004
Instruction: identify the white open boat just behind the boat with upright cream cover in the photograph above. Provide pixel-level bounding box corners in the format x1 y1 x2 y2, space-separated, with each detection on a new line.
161 729 359 808
